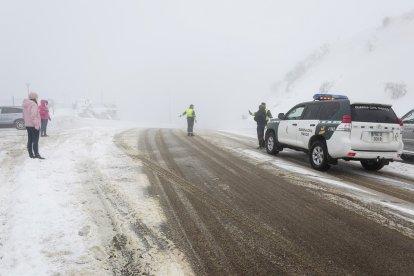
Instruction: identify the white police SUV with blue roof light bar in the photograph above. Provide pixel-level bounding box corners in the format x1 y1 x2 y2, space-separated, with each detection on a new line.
265 94 403 171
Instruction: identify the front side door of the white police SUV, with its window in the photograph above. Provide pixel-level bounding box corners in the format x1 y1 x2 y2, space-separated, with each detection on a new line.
277 104 305 147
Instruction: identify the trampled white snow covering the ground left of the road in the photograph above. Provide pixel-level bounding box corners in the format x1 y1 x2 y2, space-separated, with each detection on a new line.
0 111 189 275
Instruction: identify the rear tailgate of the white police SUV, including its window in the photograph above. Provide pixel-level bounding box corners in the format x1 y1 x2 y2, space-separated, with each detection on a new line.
351 103 401 152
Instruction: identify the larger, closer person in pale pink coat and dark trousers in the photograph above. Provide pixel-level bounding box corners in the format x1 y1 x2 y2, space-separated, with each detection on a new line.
23 92 44 159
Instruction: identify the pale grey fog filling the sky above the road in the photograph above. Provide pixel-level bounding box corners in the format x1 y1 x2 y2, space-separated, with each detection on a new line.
0 0 414 128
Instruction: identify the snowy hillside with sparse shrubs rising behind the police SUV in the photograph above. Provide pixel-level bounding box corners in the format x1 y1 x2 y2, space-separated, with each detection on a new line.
268 11 414 116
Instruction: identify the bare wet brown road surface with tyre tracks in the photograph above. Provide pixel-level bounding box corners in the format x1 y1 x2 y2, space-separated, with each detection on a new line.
116 129 414 275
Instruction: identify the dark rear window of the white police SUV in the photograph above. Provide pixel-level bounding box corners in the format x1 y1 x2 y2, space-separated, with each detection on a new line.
351 104 398 124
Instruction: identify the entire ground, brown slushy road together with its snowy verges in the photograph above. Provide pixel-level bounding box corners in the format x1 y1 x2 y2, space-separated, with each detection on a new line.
0 116 414 275
